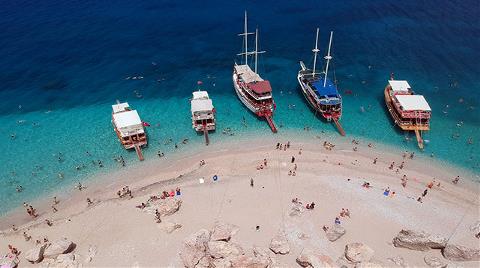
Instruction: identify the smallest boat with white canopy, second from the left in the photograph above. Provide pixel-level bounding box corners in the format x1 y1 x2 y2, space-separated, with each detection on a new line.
190 90 215 145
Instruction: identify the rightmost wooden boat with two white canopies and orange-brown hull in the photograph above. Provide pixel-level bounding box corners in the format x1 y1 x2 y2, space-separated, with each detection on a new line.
384 77 432 149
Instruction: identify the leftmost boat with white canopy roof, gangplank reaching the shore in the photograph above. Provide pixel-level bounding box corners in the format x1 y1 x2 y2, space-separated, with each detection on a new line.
112 101 147 160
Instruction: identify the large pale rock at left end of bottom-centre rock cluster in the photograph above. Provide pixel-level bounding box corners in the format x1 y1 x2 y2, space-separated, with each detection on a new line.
180 229 210 268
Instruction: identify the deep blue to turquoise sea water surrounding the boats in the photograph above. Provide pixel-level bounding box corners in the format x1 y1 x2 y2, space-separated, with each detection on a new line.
0 0 480 213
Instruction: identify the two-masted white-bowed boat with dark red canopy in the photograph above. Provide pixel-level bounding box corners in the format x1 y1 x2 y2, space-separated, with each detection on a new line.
232 11 277 133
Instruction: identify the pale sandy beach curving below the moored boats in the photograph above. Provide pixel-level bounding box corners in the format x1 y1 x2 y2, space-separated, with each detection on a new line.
0 135 480 267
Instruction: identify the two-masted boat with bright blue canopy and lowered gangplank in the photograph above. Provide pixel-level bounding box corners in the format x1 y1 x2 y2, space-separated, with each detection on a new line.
297 28 345 136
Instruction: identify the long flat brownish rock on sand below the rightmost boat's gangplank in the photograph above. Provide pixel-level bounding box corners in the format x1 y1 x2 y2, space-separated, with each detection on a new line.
393 229 447 251
